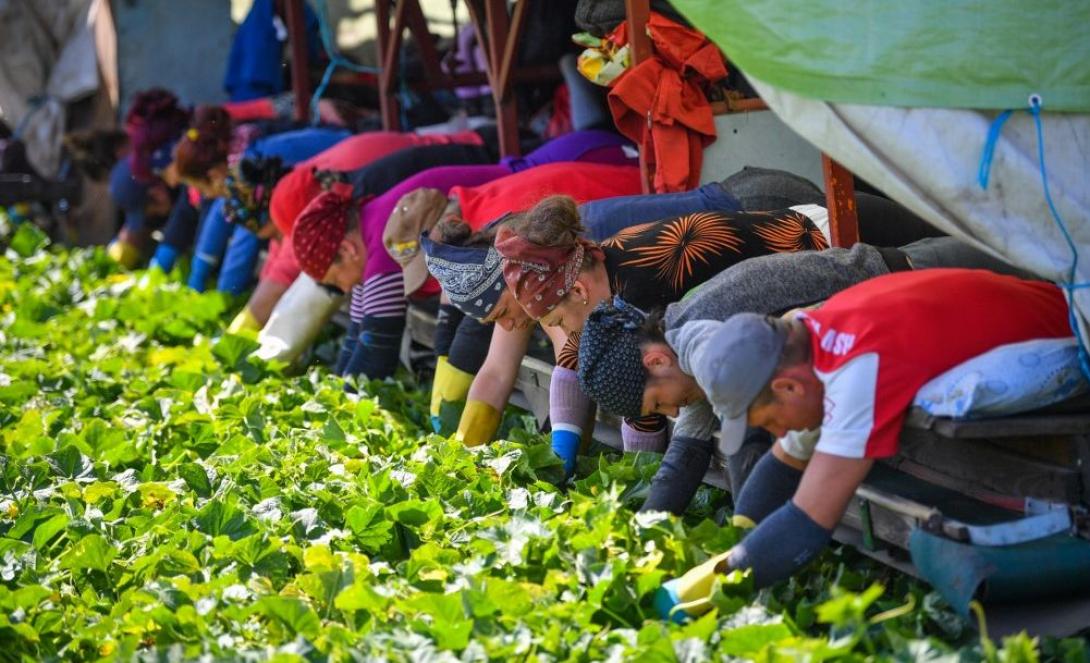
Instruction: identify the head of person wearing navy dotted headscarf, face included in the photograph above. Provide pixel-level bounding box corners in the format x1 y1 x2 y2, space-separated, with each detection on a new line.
579 298 704 418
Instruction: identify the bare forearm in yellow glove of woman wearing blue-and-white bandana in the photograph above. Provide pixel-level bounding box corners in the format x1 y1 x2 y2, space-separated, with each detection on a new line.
457 327 533 446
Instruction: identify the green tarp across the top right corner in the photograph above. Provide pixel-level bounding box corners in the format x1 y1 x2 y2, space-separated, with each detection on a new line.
671 0 1090 111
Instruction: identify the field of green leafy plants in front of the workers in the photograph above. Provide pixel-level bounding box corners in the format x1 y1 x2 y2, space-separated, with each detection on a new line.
0 228 1087 661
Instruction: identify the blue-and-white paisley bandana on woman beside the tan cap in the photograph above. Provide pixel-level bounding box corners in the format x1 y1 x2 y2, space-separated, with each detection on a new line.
420 231 507 320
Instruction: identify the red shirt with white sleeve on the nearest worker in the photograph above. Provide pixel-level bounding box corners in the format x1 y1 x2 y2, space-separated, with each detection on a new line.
800 269 1071 458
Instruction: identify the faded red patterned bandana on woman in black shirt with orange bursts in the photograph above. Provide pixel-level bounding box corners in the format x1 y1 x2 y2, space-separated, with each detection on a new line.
496 233 604 320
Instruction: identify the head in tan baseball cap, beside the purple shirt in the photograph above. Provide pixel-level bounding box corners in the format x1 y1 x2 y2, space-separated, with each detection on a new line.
383 189 448 296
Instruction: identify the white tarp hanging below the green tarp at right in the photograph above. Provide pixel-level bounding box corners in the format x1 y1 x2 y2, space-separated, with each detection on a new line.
751 79 1090 357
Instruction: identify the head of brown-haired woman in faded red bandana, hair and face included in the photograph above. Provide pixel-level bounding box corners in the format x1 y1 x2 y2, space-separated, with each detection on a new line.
496 195 611 334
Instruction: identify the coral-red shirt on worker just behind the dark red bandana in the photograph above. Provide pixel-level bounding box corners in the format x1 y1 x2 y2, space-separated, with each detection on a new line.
269 131 484 237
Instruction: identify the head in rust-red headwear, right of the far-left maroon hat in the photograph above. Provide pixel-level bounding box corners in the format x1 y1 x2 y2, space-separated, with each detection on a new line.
173 106 231 197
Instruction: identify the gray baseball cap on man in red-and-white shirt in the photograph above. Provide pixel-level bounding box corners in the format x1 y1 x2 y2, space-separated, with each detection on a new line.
666 313 788 454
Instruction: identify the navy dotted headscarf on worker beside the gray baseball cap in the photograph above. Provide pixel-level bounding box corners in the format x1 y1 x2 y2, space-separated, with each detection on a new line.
579 297 647 419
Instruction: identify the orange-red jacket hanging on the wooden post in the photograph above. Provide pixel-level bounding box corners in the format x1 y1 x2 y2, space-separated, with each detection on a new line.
609 13 727 193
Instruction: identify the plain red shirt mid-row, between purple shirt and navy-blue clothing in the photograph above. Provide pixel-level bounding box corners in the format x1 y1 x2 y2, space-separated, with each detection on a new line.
450 161 643 230
